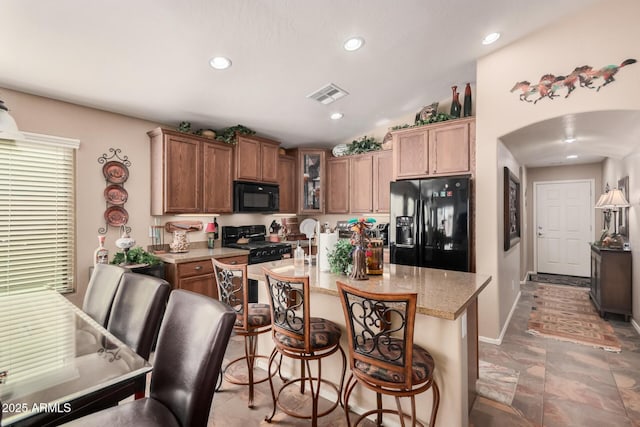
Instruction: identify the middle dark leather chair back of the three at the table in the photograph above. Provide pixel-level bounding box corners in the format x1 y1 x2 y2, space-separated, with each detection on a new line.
107 272 171 360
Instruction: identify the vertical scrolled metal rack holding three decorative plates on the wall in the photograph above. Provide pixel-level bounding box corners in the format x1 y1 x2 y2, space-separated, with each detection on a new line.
98 148 131 234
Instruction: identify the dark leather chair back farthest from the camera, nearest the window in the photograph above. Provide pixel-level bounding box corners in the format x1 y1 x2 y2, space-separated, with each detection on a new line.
82 264 127 328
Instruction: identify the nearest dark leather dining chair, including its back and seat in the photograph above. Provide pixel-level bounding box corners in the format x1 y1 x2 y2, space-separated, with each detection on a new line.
64 290 236 427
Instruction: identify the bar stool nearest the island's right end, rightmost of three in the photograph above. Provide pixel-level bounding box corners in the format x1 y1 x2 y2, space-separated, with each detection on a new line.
336 281 440 427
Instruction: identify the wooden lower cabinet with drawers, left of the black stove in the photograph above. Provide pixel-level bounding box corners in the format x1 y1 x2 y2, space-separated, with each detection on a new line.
166 255 249 299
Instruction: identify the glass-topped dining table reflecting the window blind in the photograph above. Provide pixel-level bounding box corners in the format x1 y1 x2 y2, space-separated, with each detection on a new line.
0 287 152 427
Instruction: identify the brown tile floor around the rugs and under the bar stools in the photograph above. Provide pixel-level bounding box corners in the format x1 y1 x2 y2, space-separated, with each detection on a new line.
208 283 640 427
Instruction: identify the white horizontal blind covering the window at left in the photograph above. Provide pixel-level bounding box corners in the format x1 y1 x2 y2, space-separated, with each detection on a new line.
0 133 79 293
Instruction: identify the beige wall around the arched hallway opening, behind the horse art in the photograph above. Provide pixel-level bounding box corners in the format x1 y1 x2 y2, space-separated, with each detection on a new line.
476 0 640 339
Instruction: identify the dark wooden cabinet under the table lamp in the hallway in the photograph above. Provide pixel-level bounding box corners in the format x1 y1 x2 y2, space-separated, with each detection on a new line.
590 245 633 321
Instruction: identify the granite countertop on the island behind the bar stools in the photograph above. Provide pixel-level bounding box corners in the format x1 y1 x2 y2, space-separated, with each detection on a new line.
248 259 491 320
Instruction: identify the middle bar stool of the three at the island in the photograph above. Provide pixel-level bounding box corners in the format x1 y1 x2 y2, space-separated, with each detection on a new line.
262 267 347 427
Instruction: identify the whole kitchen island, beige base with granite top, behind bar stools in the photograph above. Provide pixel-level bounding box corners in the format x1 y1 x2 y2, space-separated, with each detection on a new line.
248 260 491 427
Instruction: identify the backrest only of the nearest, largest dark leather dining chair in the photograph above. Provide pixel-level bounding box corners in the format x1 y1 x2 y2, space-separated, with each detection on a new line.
150 290 236 427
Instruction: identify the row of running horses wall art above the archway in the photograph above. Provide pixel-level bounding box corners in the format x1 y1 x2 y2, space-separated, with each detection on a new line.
511 58 637 104
